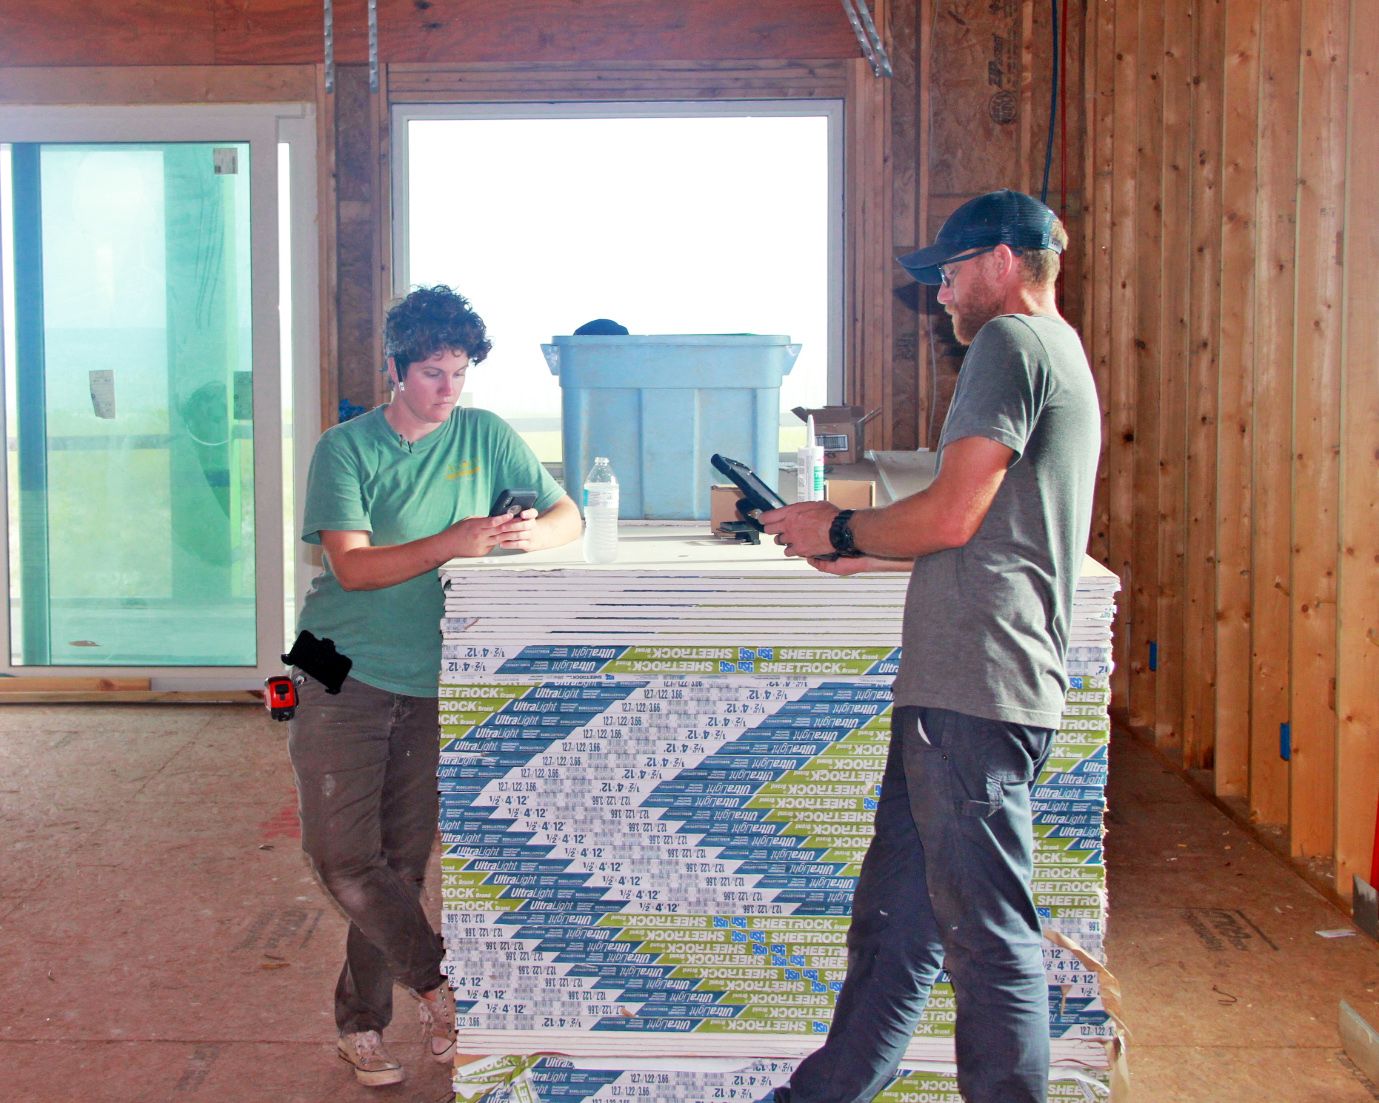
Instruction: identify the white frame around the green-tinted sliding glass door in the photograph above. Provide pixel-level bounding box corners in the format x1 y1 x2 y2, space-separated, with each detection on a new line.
0 103 321 691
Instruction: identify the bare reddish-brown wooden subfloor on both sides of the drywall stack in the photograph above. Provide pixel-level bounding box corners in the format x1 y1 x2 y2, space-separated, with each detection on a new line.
0 705 1379 1103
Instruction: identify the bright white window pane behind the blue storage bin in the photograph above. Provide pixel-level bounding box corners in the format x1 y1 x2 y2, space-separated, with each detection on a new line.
399 103 841 462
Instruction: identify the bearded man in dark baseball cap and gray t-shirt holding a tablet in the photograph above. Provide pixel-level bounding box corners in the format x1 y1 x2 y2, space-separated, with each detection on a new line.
761 190 1100 1103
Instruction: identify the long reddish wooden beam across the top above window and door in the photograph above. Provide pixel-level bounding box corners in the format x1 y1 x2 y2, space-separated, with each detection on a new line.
0 0 860 65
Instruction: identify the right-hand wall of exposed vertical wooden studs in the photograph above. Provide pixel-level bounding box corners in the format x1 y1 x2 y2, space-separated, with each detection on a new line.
1085 0 1379 896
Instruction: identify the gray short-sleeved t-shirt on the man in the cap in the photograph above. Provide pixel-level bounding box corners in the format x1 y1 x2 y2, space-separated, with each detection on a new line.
895 314 1100 728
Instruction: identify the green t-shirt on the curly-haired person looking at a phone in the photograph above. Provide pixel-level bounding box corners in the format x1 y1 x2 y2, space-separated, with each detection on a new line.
296 407 564 698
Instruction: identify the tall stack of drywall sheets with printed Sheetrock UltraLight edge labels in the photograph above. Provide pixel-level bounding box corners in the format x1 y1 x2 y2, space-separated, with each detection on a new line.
441 569 1116 1103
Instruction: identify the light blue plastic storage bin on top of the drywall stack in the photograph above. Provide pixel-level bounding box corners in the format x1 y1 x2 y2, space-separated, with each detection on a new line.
541 334 800 520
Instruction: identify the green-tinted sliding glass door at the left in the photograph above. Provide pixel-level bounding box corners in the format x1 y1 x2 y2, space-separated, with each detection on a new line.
0 109 314 682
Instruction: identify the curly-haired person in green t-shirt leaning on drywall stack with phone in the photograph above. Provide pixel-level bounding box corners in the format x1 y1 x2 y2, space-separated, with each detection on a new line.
288 287 581 1086
